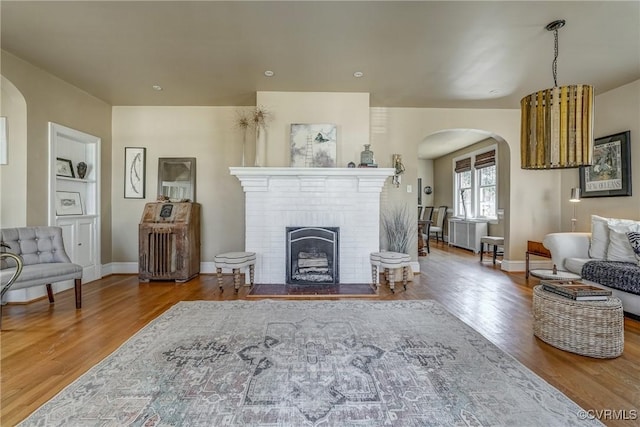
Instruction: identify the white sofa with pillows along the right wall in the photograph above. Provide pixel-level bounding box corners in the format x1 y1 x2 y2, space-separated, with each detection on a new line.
542 215 640 316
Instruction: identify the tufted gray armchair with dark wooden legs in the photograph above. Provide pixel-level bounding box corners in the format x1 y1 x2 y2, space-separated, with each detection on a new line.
0 227 82 320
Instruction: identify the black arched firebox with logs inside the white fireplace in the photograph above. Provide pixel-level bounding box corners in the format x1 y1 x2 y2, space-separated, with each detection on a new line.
286 227 340 285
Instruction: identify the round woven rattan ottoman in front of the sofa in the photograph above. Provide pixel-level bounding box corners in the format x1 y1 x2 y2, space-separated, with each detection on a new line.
533 285 624 359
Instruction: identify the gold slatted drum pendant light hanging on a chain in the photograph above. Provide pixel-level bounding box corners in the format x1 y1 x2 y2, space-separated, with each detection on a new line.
520 20 594 169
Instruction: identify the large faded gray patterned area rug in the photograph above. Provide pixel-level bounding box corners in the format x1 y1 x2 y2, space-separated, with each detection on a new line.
21 300 601 426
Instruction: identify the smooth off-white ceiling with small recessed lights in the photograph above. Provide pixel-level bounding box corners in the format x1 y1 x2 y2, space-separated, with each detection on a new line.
0 0 640 158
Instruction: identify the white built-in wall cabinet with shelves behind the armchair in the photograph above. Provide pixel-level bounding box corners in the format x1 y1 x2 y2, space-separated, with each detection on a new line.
49 123 102 283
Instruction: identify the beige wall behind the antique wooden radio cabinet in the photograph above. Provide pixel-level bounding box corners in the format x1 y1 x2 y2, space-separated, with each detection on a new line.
111 107 248 263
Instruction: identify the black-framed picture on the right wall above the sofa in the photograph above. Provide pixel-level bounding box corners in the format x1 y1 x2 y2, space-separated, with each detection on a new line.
580 131 631 198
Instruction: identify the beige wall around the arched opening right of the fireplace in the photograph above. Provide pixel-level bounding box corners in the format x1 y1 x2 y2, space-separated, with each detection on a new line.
371 107 560 271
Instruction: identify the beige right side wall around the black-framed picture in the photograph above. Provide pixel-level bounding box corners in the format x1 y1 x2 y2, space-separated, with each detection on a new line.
557 80 640 227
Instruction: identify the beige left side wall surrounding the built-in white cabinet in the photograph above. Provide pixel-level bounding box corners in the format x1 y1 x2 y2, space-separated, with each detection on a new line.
2 51 111 264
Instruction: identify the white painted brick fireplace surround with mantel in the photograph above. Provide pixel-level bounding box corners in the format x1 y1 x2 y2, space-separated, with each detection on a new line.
229 167 394 284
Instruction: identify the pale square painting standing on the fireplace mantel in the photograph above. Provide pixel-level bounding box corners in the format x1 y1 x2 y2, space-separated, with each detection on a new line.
290 123 337 168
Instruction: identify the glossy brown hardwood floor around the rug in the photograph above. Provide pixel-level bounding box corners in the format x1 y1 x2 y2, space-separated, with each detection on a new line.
0 242 640 426
